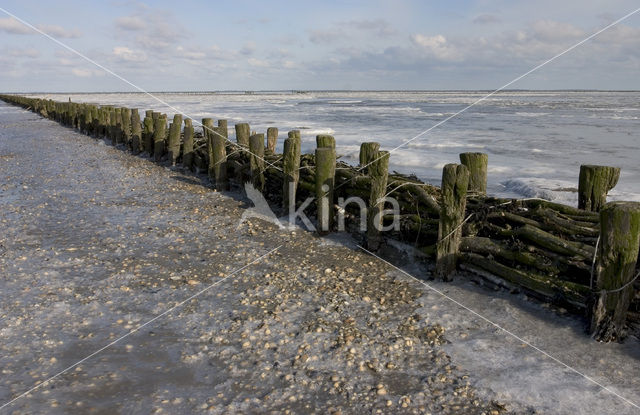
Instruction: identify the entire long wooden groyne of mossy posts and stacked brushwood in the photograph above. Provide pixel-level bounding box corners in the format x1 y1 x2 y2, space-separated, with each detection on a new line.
0 95 640 341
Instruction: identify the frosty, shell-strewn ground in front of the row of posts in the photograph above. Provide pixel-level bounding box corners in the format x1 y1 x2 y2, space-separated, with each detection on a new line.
0 101 640 414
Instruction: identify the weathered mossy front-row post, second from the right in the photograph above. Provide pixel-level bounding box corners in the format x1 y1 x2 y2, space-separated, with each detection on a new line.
436 163 469 281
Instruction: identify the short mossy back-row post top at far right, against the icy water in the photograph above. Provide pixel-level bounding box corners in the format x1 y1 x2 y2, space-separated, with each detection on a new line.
578 164 620 212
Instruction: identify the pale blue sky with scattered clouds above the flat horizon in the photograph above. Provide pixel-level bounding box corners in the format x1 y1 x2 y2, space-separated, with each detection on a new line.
0 0 640 92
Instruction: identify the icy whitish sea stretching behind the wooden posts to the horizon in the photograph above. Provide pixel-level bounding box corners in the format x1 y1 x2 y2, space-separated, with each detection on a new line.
30 91 640 205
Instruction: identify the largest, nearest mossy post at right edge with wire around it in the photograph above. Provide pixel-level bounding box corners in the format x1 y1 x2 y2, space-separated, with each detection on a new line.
590 202 640 342
